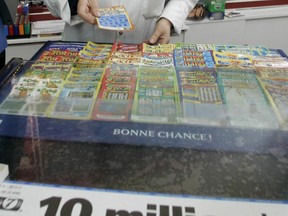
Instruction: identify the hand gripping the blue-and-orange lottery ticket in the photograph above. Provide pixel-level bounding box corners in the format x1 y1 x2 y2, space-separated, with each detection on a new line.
77 0 100 24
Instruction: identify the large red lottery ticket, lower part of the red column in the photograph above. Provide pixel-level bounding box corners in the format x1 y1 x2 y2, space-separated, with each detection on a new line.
92 65 137 121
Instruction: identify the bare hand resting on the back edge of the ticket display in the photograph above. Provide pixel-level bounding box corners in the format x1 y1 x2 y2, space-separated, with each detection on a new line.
148 18 172 44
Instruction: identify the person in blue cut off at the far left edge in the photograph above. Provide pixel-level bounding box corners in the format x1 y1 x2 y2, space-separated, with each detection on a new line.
0 0 12 69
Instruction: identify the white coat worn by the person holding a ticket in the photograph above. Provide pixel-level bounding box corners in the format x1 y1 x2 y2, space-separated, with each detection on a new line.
44 0 198 43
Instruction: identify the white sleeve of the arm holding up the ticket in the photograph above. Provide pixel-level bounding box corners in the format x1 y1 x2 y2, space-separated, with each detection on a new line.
44 0 83 25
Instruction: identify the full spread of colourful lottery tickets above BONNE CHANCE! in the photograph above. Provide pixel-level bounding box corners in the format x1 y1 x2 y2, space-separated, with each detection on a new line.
0 42 288 129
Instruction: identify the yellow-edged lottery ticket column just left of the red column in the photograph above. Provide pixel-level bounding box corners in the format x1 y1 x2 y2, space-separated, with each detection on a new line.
49 42 112 119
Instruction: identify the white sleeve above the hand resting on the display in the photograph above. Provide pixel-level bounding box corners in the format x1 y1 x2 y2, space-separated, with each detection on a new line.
160 0 198 34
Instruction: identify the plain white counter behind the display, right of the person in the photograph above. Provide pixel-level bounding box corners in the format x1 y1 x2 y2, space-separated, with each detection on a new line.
185 6 288 54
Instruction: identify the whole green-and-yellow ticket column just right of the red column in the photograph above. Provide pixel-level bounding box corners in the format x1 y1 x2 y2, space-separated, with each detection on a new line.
131 44 180 123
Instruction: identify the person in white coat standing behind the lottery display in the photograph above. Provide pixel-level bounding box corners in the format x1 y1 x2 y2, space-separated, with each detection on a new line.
44 0 198 44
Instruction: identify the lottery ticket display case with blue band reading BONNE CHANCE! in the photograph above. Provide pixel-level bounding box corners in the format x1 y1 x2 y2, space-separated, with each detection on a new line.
0 42 288 216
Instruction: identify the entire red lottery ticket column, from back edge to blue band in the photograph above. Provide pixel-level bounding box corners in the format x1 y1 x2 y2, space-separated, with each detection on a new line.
92 42 142 121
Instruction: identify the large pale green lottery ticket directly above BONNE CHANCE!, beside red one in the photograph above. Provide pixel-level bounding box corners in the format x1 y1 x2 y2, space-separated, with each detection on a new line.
132 66 180 123
